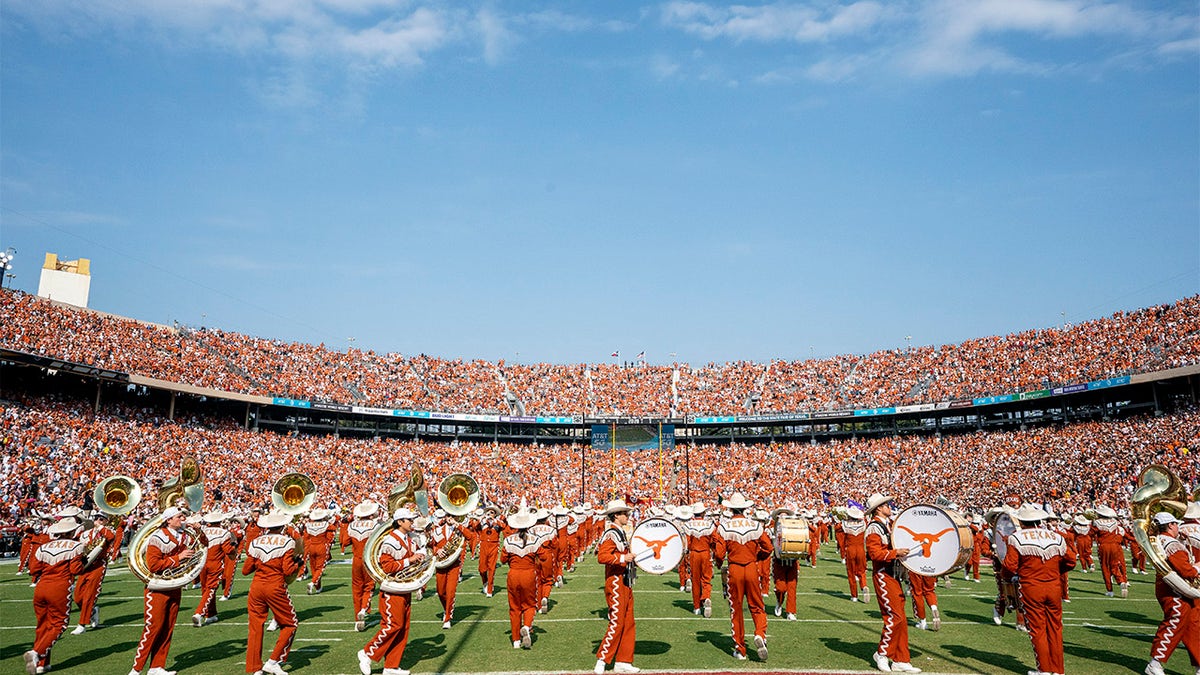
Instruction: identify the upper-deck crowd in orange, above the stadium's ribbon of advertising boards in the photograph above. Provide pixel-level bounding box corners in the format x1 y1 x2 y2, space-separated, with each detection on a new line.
0 289 1200 417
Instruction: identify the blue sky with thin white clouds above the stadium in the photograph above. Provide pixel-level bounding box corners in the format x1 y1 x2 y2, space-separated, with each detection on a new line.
0 0 1200 364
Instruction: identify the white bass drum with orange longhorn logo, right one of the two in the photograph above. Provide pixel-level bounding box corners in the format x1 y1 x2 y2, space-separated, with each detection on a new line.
892 504 974 577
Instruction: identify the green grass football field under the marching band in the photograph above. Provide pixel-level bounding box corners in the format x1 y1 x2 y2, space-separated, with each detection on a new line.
0 544 1180 675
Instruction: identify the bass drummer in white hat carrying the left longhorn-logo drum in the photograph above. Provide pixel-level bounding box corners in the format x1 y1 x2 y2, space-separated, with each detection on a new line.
593 500 641 675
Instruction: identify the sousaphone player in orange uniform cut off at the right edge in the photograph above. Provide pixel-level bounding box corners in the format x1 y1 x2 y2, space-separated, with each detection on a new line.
1146 502 1200 675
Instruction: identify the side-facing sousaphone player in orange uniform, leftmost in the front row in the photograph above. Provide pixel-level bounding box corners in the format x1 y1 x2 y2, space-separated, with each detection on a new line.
130 507 196 675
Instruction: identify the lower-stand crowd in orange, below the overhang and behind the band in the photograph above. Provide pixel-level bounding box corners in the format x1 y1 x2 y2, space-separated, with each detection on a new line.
0 398 1200 522
